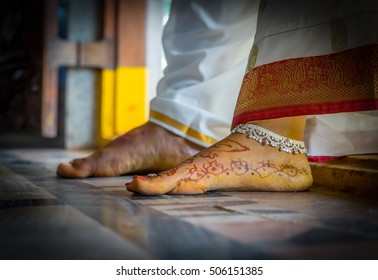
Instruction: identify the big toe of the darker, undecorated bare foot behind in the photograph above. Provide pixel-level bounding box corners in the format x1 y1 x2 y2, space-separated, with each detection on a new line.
56 159 92 178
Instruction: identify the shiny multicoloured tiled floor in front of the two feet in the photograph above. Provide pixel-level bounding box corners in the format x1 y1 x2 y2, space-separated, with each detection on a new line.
0 150 378 259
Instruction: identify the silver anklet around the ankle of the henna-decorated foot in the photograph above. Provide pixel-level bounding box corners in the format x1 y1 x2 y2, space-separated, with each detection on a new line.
231 123 307 155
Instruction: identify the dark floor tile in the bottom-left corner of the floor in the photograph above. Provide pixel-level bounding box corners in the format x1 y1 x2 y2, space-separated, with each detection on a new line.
0 205 153 259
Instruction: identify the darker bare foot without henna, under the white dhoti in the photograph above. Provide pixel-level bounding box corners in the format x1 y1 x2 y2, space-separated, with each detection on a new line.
56 123 202 178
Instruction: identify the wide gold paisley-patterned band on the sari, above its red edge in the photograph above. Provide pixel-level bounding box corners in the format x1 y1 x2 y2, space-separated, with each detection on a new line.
235 45 378 116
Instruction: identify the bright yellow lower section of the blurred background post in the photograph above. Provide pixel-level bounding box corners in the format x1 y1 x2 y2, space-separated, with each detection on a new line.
97 67 149 146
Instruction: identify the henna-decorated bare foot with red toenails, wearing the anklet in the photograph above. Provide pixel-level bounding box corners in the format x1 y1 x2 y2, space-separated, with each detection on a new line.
126 117 312 195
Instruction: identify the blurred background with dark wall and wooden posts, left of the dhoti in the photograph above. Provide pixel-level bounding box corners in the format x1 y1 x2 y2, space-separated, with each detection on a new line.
0 0 170 149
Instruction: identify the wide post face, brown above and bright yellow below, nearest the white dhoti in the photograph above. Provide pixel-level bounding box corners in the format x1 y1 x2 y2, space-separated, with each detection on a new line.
115 0 148 134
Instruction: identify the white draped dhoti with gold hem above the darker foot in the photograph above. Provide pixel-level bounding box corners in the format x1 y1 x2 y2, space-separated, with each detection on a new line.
150 0 258 147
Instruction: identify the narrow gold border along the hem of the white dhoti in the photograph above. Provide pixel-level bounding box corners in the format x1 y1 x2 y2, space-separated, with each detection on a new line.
150 110 217 145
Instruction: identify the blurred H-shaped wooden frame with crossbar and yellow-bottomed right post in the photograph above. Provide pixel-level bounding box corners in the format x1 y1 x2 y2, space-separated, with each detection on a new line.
42 0 148 142
